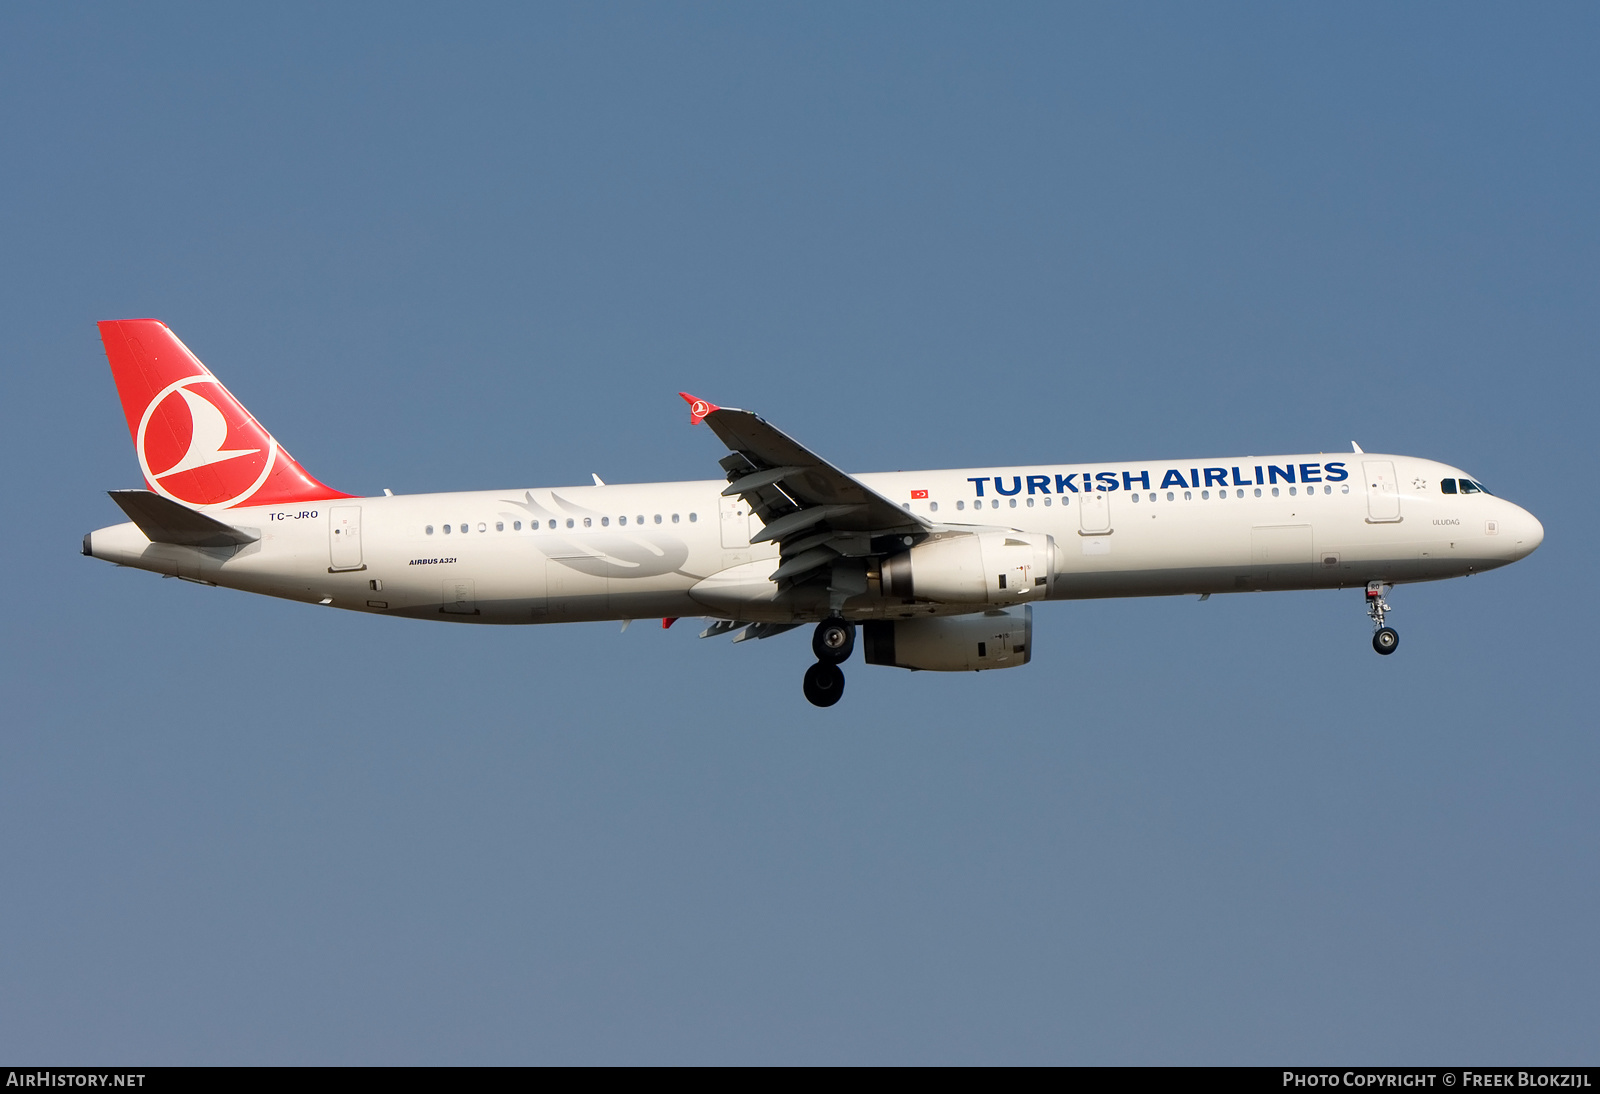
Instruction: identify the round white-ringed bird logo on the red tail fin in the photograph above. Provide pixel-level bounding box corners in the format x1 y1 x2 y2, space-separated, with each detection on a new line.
134 373 278 509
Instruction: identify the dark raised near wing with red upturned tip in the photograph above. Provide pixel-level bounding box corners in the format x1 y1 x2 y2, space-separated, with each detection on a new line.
680 392 931 584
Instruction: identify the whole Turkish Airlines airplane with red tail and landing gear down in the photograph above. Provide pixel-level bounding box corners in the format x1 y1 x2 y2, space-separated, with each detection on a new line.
83 320 1544 707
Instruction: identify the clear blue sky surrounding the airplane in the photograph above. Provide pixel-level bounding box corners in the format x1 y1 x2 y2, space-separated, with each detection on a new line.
0 5 1600 1064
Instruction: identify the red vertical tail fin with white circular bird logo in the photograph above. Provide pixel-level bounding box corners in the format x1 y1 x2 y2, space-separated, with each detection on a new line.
99 320 350 509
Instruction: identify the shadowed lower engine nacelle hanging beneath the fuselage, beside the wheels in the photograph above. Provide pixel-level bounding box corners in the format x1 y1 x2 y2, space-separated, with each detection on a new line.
861 605 1034 672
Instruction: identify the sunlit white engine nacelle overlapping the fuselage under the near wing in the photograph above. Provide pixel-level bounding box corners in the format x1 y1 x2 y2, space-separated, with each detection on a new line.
882 529 1054 605
